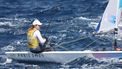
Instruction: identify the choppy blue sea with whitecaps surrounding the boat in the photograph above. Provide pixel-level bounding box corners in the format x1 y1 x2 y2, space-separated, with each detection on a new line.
0 0 121 69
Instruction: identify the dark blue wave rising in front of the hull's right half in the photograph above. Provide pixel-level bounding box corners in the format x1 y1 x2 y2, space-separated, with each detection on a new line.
64 56 120 69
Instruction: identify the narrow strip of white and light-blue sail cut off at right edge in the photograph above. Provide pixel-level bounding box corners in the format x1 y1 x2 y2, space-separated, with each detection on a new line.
117 0 122 39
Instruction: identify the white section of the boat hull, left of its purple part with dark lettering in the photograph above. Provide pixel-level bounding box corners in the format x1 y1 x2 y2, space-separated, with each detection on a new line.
5 51 93 64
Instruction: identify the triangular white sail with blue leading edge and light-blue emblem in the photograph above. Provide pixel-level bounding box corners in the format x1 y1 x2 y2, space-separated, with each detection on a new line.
96 0 119 33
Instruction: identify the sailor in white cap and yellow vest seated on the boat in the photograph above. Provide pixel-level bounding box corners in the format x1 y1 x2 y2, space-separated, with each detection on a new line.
27 19 46 53
